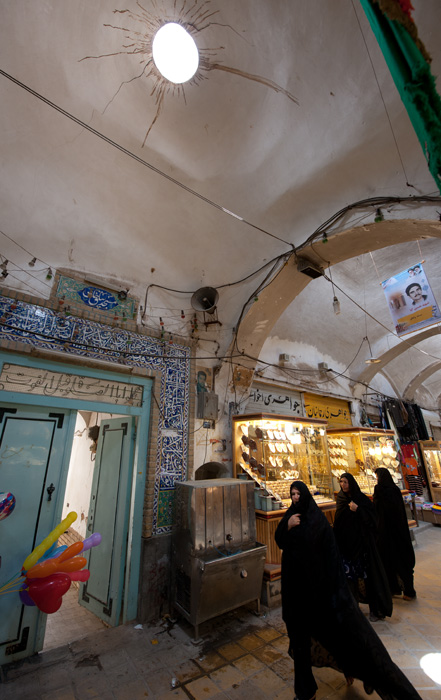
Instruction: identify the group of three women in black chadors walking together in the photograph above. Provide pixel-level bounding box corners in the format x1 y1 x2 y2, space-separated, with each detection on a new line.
275 469 421 700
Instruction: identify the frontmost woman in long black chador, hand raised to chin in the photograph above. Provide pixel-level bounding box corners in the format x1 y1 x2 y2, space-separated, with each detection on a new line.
275 481 421 700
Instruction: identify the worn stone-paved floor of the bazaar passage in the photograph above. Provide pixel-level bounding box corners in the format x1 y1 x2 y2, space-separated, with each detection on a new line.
0 526 441 700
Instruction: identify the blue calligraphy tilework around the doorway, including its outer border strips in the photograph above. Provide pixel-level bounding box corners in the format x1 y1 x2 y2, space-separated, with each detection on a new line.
0 284 194 537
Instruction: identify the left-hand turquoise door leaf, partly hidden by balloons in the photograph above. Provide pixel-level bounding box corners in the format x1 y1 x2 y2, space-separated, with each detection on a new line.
0 404 73 664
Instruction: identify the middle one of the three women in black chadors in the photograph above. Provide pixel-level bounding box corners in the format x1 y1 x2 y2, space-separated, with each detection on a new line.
334 472 392 621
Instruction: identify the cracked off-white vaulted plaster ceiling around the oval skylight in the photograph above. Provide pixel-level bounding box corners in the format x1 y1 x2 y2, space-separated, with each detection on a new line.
0 0 441 410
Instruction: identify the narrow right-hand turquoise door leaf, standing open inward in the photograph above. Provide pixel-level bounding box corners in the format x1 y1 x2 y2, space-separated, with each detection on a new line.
79 416 135 626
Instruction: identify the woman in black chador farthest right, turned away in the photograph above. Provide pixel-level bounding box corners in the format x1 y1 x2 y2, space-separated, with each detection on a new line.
374 467 416 600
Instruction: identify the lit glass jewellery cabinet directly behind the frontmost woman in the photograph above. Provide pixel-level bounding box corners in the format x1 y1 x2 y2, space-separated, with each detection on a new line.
233 413 334 510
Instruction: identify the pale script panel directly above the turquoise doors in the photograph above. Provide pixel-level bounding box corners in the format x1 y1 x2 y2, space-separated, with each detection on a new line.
0 363 142 407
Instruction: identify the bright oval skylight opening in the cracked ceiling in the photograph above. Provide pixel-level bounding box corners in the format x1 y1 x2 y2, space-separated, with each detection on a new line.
152 22 199 84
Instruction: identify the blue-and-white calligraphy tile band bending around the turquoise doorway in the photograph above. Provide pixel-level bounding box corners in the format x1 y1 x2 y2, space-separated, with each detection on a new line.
0 296 190 535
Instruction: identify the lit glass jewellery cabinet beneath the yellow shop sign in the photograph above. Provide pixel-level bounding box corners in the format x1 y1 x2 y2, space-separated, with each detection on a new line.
327 428 405 495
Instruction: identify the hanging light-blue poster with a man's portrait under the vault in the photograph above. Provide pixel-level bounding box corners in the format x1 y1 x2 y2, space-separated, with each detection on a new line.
381 263 441 336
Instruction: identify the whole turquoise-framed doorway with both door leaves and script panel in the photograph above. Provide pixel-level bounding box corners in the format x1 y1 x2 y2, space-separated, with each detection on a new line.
0 355 152 665
